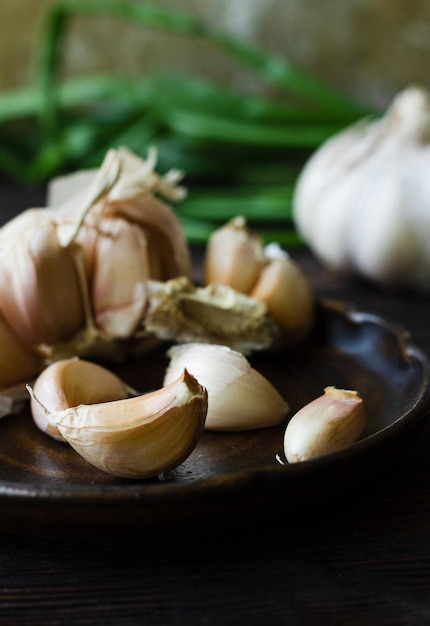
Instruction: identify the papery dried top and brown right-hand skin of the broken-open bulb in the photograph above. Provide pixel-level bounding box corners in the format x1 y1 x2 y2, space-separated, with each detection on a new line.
48 148 191 280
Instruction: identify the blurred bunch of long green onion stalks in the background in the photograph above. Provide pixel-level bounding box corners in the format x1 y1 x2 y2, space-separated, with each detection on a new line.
0 0 375 247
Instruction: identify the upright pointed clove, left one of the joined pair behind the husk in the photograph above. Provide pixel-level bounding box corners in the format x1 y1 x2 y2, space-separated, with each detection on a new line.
205 217 265 293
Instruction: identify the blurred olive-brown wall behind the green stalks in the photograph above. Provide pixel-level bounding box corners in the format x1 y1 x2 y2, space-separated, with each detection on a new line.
0 0 430 106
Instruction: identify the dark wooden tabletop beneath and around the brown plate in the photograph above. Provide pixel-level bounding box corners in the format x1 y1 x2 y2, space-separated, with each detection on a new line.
0 185 430 626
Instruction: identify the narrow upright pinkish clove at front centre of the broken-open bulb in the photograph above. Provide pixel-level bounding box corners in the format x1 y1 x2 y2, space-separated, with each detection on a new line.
91 218 149 338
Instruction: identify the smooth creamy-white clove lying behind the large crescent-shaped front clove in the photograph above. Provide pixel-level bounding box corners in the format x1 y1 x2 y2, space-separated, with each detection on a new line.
164 343 289 431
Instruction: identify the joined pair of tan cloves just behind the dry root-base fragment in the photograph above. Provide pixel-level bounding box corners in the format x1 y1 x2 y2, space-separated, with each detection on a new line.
205 217 314 347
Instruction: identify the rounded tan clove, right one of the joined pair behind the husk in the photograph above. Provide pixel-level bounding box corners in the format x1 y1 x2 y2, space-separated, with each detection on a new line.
249 247 314 347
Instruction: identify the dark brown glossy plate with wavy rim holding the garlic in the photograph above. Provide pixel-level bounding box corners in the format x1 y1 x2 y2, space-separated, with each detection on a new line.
0 302 430 534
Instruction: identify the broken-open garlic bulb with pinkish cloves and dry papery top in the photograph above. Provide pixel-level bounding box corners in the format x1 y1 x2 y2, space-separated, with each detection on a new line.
0 149 191 389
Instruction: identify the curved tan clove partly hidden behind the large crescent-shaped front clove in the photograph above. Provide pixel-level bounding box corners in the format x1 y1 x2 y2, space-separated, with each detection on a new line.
30 358 130 441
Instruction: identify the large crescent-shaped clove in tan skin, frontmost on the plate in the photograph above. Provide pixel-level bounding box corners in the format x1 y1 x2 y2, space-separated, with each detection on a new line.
29 364 207 478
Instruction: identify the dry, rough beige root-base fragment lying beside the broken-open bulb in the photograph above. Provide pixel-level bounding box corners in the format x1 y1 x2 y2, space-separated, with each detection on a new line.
143 277 277 354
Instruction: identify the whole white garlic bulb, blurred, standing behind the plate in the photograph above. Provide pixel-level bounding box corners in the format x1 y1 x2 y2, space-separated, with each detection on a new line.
293 87 430 291
